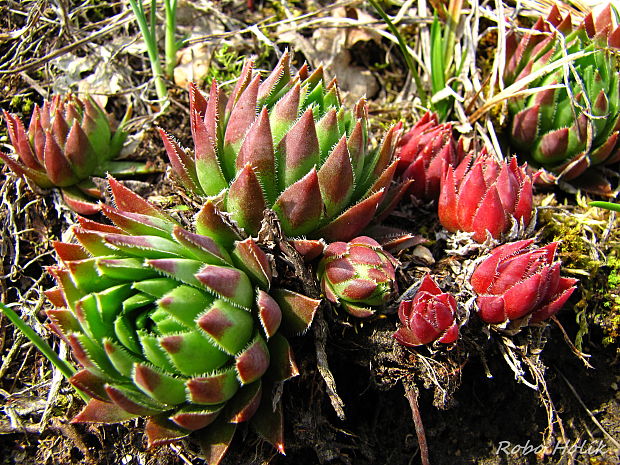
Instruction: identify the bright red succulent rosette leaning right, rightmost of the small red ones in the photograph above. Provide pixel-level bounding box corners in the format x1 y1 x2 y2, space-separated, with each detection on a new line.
470 239 577 324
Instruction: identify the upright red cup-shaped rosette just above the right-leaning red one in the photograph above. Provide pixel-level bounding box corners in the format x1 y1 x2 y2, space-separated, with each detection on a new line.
438 149 537 242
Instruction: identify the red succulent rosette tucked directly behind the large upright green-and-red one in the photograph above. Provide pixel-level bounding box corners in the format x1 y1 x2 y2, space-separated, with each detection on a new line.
396 112 464 201
